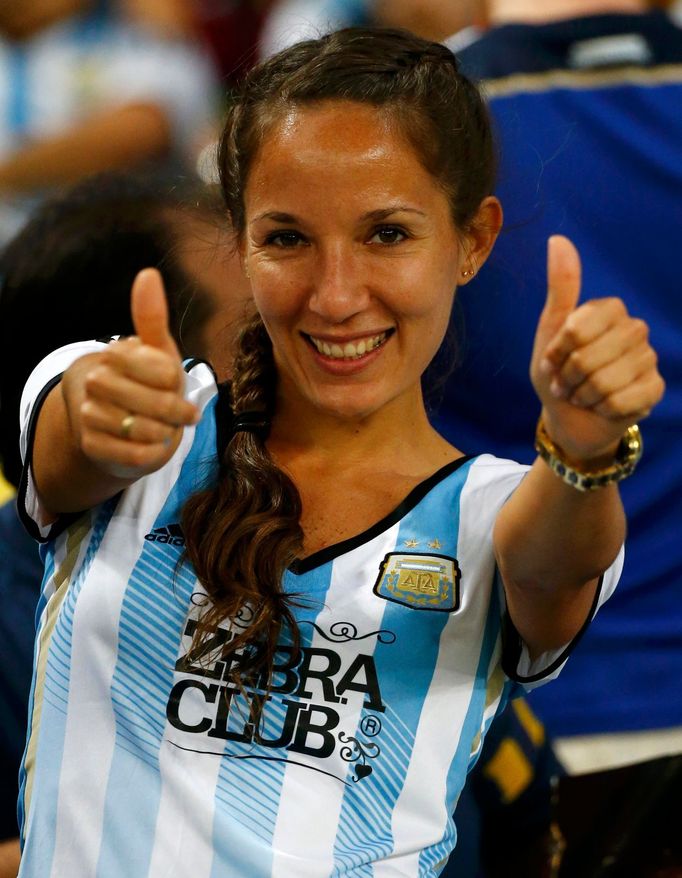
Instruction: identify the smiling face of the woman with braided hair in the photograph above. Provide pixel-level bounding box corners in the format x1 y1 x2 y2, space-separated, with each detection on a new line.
242 101 486 419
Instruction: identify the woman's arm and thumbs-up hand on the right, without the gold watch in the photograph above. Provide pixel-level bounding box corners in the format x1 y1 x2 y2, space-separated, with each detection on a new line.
494 239 664 656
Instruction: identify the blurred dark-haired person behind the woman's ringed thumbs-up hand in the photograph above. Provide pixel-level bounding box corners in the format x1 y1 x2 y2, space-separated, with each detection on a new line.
0 173 251 878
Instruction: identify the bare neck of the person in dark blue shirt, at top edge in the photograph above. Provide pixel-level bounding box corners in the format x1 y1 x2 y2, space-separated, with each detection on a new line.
488 0 649 25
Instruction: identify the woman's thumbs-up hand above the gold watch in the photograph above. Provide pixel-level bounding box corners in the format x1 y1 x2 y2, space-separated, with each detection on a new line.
530 236 665 468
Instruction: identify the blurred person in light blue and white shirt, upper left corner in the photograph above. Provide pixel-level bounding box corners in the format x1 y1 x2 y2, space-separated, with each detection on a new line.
0 0 217 243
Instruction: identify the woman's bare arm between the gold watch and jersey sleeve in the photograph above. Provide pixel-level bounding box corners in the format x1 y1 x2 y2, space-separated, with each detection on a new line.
494 459 625 653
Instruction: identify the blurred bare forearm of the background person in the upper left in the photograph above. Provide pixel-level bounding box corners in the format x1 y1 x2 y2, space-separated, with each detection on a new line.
0 103 170 191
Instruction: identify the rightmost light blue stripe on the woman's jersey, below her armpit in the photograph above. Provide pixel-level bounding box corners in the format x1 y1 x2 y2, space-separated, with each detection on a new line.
420 548 508 868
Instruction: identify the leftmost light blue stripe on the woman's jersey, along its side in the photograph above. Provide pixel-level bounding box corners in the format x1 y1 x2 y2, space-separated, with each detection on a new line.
20 506 116 878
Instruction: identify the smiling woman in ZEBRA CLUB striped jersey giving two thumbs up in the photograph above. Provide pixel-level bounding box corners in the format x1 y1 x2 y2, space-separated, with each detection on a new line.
21 29 662 878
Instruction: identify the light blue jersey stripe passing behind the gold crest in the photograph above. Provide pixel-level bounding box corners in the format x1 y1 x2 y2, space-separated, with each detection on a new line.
332 463 470 878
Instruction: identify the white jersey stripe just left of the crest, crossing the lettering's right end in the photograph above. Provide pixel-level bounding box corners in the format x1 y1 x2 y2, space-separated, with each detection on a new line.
272 523 400 878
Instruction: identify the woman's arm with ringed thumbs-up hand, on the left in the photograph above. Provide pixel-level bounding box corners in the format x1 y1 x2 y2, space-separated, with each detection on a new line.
31 270 197 516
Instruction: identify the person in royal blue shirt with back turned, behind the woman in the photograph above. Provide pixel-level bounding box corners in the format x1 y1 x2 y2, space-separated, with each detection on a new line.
434 0 682 784
